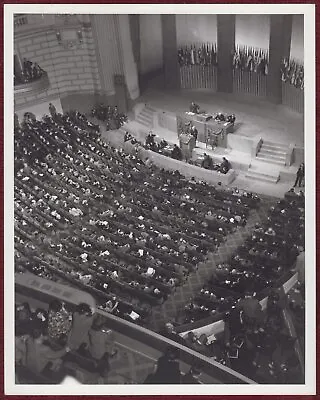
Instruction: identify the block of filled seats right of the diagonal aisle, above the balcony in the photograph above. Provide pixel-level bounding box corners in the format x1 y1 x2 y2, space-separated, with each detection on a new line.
179 195 304 323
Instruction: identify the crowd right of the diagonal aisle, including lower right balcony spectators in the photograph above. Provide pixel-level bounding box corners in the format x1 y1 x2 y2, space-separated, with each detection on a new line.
162 191 304 383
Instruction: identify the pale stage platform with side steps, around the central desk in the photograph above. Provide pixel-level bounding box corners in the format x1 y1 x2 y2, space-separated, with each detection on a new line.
118 91 304 197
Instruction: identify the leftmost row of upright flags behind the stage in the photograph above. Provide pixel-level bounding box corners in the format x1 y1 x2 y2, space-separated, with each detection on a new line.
178 43 218 66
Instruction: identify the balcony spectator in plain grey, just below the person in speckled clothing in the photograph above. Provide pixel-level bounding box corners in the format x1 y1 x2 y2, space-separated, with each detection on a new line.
26 329 70 376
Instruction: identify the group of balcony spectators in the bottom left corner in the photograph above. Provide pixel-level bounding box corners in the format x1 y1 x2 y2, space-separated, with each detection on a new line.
15 300 118 384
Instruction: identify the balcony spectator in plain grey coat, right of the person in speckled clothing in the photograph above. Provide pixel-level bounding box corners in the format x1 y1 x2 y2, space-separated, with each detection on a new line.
68 303 93 350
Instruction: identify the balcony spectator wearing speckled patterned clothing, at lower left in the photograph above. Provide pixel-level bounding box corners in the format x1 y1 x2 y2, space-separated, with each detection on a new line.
48 300 72 342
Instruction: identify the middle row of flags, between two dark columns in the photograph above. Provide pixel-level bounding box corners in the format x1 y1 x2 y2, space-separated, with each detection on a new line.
232 46 269 75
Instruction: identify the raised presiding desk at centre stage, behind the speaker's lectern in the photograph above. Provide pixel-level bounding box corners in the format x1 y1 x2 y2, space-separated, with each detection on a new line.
177 112 234 147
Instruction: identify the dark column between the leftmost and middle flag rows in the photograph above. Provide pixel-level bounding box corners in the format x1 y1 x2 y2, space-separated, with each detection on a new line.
217 14 236 93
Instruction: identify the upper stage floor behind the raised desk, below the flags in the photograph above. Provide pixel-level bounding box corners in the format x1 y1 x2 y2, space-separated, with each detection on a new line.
137 90 304 147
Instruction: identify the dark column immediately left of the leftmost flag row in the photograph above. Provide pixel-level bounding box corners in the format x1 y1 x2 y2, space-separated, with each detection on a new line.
161 14 180 89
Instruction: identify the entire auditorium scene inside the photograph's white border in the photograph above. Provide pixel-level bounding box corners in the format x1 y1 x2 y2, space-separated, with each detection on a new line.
12 14 305 387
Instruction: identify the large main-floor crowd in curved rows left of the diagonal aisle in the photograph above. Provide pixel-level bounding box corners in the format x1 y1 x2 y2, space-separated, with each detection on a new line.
14 108 259 324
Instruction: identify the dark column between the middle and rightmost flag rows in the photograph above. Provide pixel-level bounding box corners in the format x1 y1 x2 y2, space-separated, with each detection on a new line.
267 14 292 104
